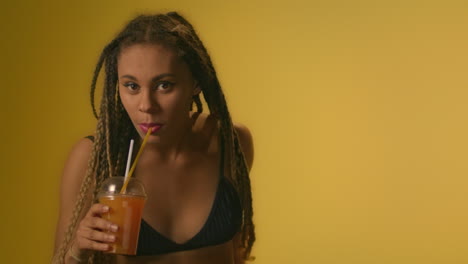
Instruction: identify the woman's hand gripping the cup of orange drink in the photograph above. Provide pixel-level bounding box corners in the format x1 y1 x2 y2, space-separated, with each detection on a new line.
70 204 118 260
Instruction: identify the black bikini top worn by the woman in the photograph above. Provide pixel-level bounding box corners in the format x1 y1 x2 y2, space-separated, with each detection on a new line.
86 135 242 256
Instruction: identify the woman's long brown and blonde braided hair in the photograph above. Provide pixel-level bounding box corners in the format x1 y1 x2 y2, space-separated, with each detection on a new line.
54 12 255 263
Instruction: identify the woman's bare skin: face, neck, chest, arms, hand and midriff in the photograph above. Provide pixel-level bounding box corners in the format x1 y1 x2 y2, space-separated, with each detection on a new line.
56 45 253 264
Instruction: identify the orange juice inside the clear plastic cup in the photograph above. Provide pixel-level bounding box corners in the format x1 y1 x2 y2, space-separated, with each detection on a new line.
99 193 146 255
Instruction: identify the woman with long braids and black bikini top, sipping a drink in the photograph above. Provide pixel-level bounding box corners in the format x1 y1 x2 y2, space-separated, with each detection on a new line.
54 12 255 263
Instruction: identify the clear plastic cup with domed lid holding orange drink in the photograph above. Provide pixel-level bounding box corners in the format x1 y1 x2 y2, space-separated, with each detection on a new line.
98 177 146 255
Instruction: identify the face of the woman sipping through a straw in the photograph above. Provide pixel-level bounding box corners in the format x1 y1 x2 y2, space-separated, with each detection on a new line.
117 44 200 143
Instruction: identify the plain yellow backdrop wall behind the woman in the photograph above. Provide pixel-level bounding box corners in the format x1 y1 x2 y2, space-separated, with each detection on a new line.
0 0 468 264
